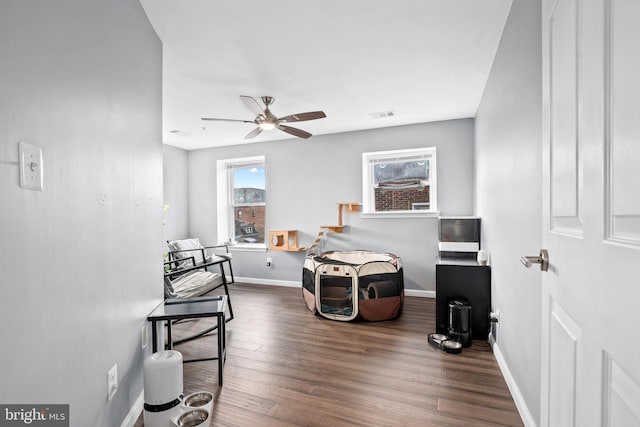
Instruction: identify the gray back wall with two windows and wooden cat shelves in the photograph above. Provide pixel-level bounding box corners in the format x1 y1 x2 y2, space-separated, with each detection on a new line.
182 119 474 291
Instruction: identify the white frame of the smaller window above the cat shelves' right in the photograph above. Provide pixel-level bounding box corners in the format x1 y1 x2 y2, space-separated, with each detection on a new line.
361 147 439 218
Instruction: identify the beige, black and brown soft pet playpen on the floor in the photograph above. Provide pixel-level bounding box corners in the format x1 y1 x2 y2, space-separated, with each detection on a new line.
302 251 404 321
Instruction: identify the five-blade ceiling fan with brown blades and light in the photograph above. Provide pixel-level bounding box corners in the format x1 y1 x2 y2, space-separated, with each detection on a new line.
202 95 327 139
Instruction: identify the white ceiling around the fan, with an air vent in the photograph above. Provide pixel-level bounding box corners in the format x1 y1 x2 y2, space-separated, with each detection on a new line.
141 0 511 149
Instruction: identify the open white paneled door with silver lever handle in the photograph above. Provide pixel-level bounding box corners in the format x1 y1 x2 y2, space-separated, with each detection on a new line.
544 0 640 427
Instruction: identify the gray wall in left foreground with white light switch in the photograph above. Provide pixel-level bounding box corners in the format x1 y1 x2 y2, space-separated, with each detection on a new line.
0 0 163 427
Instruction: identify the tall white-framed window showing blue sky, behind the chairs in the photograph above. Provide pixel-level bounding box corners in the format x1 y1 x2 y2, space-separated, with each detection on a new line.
217 156 267 249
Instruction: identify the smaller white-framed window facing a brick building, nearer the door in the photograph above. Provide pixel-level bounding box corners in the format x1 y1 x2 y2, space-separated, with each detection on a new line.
362 147 438 216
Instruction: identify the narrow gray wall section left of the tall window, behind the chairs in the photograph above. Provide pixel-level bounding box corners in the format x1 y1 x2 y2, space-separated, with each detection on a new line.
162 145 189 241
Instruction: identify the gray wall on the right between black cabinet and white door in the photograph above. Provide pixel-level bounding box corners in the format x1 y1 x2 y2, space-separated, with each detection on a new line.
476 0 542 424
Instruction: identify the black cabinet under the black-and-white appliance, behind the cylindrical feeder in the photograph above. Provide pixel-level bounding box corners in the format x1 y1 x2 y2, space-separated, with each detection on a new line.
436 260 491 340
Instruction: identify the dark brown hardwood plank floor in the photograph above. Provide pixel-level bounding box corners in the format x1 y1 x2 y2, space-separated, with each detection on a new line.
136 284 522 427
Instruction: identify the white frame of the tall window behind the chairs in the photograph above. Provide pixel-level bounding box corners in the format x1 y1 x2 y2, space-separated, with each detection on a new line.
216 155 268 252
